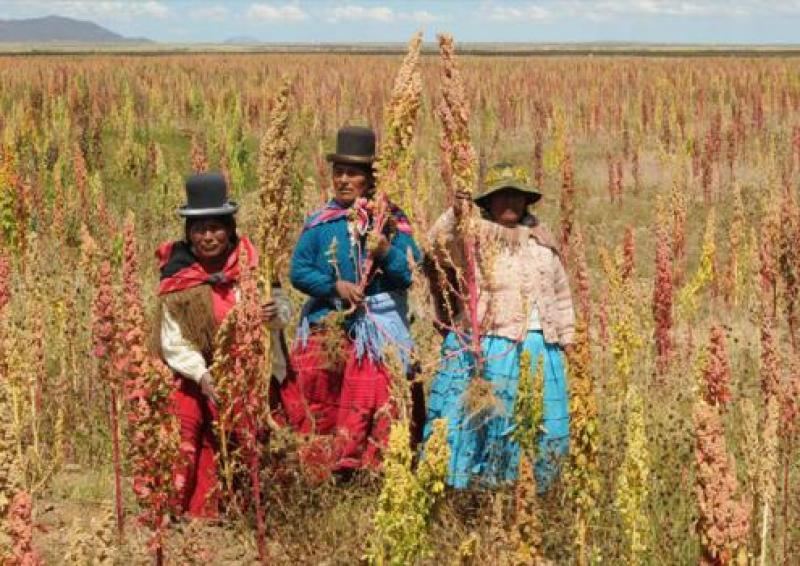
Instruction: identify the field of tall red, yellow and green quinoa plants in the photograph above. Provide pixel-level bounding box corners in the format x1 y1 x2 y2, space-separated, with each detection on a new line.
0 40 800 565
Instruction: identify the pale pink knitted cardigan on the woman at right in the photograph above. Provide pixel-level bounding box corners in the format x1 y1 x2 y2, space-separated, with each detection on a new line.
428 208 575 346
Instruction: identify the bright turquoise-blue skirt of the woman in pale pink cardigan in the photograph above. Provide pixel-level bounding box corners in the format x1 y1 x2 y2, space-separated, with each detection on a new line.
424 331 569 491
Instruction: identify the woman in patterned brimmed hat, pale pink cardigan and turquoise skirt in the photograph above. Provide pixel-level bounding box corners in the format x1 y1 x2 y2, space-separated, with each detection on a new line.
425 163 574 488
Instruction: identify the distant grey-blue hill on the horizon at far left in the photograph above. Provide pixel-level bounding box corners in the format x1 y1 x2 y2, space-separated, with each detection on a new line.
0 16 150 43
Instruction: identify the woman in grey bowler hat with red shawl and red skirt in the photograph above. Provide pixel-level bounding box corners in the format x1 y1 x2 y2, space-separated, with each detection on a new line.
156 173 291 517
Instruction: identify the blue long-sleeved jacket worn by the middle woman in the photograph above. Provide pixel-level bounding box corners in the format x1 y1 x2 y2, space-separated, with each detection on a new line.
290 201 422 324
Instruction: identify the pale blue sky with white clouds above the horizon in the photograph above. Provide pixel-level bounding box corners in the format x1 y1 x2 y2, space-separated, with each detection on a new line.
0 0 800 44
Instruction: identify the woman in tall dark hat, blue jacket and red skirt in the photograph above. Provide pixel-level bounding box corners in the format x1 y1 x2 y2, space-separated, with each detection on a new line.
282 127 421 478
